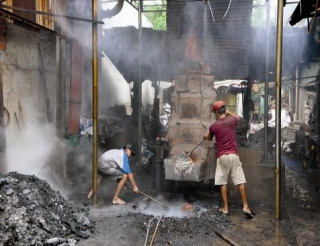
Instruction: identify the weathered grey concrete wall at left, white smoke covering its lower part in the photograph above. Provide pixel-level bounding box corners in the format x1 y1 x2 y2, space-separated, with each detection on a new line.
0 23 65 182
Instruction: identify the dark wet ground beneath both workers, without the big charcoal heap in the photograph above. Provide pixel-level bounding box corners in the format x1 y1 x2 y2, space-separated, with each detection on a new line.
71 156 320 246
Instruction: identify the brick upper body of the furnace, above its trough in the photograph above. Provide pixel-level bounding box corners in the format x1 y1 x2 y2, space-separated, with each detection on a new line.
167 75 216 147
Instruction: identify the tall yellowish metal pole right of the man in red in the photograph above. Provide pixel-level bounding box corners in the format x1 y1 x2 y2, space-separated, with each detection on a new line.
275 0 283 220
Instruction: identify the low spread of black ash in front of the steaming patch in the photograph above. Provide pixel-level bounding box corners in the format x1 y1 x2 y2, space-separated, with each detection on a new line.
128 203 233 246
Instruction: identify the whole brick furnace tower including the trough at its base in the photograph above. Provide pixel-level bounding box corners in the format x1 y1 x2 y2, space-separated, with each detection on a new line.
164 73 217 181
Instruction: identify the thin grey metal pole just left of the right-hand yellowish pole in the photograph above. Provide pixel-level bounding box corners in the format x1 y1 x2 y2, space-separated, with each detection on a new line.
263 1 270 160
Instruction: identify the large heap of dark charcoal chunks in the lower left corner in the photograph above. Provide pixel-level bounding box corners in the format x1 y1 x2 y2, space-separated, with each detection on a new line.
0 172 94 246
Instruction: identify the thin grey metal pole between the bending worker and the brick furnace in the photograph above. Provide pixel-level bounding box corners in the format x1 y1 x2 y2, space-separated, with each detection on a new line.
138 0 143 172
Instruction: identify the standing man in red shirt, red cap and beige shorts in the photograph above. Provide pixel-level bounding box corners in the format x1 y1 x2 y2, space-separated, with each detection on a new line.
203 101 254 219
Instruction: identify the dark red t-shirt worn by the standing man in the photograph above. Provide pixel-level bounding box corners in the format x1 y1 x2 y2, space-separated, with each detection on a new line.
209 116 239 157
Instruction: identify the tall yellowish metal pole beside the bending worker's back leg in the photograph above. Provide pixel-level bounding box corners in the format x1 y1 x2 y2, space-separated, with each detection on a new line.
92 0 98 205
